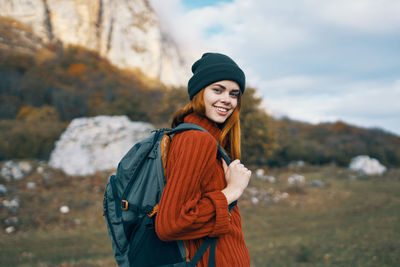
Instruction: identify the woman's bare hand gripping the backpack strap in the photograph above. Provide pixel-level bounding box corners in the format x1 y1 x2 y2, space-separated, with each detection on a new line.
221 159 251 204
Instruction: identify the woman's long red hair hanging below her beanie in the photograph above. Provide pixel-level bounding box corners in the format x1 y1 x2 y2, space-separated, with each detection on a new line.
171 89 241 160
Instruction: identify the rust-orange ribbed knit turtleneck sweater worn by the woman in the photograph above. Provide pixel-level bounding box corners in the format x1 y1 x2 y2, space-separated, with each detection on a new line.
156 113 250 267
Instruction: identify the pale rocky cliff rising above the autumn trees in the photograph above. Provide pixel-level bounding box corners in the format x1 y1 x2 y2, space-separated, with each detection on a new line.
0 0 189 85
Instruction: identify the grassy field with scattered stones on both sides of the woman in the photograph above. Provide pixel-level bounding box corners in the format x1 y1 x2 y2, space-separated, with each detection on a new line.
0 166 400 267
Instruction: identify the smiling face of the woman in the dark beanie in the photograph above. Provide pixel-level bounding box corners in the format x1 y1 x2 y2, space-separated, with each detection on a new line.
204 80 240 123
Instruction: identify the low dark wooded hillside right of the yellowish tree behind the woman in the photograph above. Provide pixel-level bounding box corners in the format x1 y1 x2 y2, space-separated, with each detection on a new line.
270 119 400 167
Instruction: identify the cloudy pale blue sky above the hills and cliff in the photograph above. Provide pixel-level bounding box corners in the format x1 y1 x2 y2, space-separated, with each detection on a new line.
150 0 400 135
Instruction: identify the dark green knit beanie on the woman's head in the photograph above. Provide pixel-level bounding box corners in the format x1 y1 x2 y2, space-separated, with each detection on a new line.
188 53 246 100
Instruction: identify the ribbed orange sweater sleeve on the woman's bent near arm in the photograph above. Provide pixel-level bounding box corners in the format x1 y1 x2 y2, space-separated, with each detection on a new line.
156 131 230 241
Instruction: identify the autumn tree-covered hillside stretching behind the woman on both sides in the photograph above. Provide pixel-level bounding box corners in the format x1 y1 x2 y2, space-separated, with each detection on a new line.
0 40 400 166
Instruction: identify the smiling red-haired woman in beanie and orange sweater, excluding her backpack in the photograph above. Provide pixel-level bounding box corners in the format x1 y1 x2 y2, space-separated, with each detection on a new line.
156 53 251 267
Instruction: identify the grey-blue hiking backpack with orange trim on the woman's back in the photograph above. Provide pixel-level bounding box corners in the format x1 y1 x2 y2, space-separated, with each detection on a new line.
103 123 236 267
